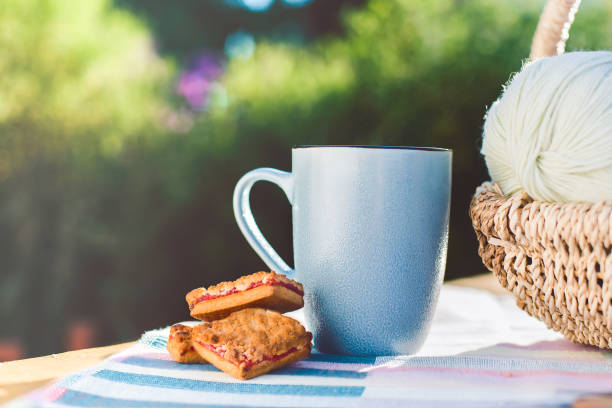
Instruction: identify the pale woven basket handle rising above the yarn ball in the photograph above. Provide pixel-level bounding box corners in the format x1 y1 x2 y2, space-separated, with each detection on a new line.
529 0 580 61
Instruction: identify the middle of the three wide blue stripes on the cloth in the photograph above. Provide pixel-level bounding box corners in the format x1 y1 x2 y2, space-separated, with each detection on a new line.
93 370 365 397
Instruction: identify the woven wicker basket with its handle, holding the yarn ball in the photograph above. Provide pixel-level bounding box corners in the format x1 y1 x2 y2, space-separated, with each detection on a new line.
470 0 612 348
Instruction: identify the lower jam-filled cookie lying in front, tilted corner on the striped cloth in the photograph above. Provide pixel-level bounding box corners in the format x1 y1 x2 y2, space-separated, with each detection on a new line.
191 308 312 380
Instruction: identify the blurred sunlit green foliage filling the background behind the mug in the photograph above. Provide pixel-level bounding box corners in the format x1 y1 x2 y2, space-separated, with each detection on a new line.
0 0 612 354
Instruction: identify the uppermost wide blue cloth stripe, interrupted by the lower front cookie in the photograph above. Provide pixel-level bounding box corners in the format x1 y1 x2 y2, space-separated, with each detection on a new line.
121 356 368 378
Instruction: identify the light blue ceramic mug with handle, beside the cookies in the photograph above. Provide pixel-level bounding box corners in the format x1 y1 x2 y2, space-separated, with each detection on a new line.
234 146 452 355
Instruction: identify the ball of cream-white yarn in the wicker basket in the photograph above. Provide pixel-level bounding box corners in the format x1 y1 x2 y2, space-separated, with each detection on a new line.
481 51 612 203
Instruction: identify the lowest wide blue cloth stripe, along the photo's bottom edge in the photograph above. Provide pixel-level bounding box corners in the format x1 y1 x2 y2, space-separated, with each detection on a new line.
55 390 300 408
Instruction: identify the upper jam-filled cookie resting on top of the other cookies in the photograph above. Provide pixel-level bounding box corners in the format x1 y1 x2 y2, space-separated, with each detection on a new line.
185 272 304 321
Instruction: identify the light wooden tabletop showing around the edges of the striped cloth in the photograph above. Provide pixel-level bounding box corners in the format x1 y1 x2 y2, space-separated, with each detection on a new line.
0 274 612 408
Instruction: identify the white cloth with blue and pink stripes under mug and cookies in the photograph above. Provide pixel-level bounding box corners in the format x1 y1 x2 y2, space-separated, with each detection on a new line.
9 285 612 408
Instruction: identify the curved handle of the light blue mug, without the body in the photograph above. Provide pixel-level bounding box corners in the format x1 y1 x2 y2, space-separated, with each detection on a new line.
234 167 295 276
